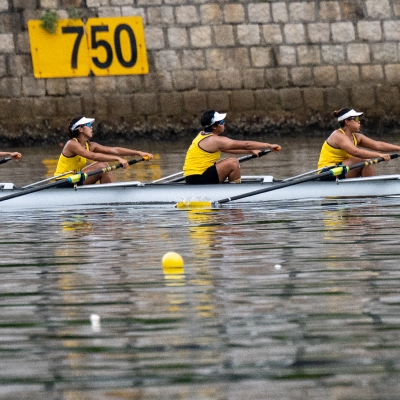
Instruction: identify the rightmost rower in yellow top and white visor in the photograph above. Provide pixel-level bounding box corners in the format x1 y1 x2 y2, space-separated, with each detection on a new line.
318 108 400 180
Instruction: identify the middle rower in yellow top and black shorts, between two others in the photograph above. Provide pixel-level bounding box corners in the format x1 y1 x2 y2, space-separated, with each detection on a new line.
183 110 281 185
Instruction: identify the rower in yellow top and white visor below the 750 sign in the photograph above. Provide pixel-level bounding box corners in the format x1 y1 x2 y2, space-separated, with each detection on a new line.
54 115 153 187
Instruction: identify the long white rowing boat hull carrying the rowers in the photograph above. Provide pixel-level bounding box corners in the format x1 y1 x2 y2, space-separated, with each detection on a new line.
0 175 400 211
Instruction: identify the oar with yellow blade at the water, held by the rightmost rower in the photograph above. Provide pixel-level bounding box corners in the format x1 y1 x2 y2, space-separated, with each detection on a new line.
176 154 399 208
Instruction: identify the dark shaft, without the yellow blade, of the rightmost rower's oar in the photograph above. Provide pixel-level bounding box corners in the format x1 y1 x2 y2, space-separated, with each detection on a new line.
215 154 399 204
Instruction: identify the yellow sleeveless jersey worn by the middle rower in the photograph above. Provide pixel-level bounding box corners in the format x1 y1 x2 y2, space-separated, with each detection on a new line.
183 132 221 178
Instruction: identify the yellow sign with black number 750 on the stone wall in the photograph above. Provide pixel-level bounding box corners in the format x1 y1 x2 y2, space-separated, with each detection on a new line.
28 17 149 78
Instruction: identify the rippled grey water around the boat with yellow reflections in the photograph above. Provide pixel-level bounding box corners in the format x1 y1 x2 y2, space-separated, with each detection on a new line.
0 138 400 400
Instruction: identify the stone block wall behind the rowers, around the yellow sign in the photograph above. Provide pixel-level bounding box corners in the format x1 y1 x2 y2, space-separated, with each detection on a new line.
0 0 400 143
